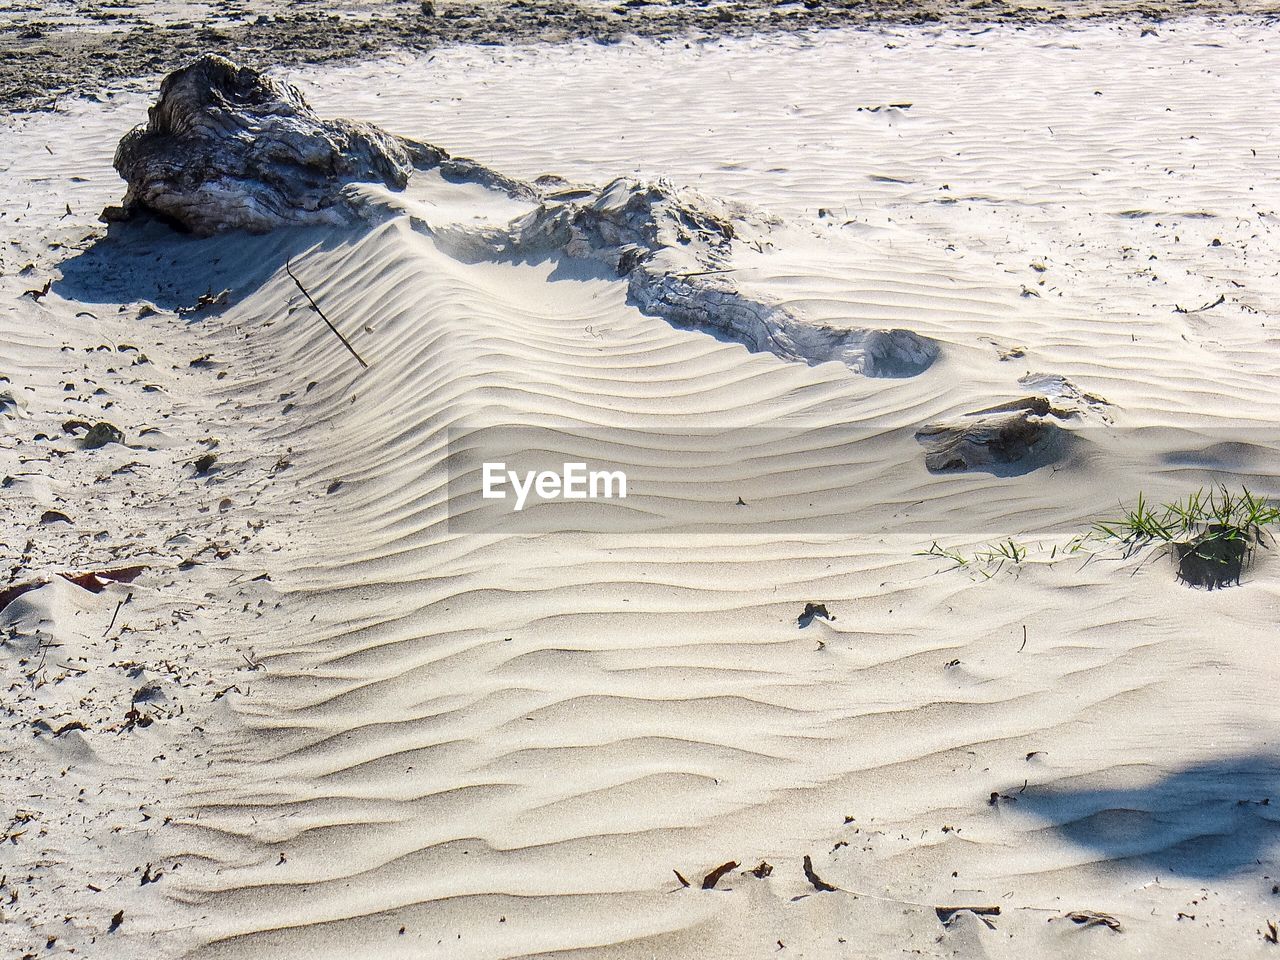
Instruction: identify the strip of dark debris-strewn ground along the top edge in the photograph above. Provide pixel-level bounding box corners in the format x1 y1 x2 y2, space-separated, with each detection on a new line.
0 0 1280 111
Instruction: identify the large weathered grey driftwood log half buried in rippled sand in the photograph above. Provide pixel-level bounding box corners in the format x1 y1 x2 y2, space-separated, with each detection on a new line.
104 55 938 376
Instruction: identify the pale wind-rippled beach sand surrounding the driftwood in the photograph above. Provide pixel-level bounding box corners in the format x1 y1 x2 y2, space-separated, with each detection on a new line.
0 19 1280 960
